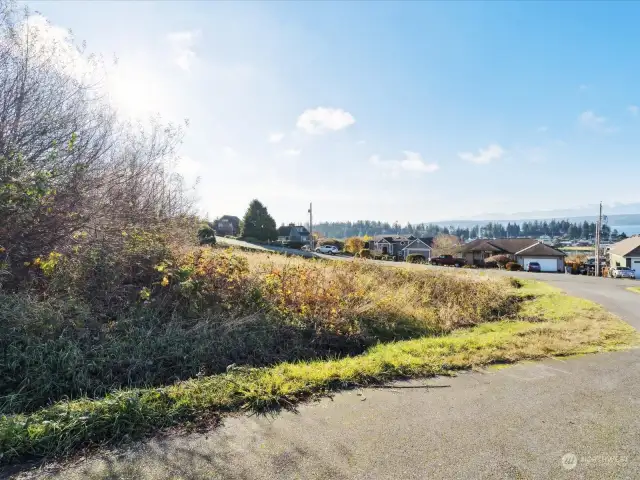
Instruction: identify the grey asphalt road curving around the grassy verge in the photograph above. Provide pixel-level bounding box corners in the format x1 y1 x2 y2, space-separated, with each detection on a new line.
8 246 640 480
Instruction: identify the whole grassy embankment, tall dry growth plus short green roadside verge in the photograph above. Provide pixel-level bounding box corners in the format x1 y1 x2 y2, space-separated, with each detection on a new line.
0 246 638 463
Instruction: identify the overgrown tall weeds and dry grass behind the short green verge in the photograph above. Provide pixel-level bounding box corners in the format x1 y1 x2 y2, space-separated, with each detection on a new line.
0 246 515 413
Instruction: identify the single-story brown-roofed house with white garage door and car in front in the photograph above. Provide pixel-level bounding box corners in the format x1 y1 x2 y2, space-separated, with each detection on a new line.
461 238 566 272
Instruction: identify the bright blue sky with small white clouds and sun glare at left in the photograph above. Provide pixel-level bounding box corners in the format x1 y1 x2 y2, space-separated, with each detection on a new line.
28 1 640 223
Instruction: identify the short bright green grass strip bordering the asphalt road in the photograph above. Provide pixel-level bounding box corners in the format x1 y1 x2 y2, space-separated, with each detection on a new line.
0 269 640 463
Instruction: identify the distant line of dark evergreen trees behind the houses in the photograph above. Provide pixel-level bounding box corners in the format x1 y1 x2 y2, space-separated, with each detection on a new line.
313 220 626 244
